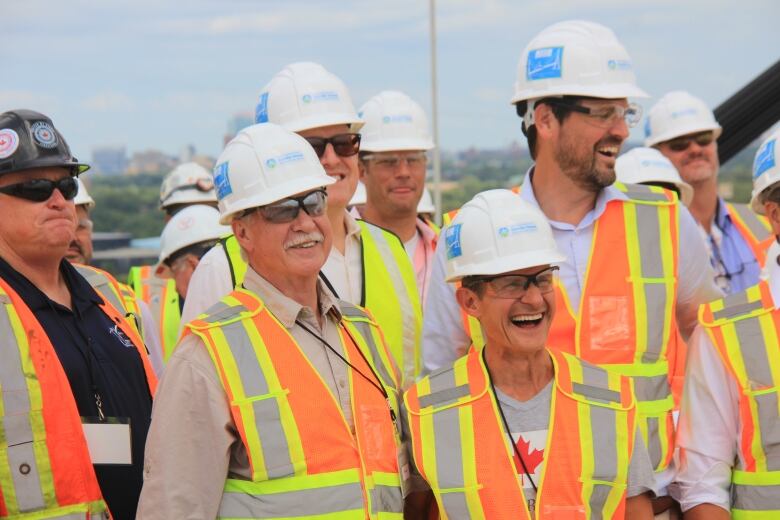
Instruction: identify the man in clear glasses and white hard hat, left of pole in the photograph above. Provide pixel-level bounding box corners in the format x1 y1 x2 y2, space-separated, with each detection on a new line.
358 90 438 302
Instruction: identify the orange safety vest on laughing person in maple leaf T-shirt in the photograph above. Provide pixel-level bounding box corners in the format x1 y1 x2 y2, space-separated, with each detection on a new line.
404 349 636 520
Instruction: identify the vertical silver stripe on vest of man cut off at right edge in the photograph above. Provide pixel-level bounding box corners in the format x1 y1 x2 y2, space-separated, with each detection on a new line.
733 310 780 471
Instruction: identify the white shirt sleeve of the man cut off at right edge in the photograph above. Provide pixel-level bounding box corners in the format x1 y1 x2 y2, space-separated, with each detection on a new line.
669 327 739 511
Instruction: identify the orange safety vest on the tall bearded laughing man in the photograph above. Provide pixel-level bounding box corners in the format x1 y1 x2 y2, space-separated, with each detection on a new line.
448 183 685 471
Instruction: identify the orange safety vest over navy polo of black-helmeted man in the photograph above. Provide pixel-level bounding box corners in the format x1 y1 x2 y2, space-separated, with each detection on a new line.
0 266 157 520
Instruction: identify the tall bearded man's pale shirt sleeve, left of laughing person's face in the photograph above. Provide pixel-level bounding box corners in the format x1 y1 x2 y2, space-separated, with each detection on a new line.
422 229 471 372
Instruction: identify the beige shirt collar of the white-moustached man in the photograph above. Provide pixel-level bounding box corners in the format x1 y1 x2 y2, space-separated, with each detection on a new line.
243 267 341 329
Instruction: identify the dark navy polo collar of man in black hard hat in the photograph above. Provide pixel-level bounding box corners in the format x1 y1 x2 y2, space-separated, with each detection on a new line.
0 258 103 314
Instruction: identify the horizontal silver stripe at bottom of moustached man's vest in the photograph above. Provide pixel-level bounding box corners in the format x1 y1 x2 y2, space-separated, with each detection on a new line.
218 482 365 518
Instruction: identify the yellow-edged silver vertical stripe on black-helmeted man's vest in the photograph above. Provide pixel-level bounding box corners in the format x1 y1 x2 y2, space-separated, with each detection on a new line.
0 289 58 516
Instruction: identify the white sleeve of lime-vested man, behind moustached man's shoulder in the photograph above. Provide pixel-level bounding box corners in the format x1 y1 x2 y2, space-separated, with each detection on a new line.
179 247 233 334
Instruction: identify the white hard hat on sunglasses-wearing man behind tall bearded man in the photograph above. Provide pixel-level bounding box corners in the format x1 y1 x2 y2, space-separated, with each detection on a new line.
645 90 723 146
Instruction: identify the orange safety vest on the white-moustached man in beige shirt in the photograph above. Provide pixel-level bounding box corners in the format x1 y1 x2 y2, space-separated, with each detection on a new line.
186 288 403 520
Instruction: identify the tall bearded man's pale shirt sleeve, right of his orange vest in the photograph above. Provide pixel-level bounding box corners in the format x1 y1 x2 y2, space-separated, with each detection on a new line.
676 204 724 339
